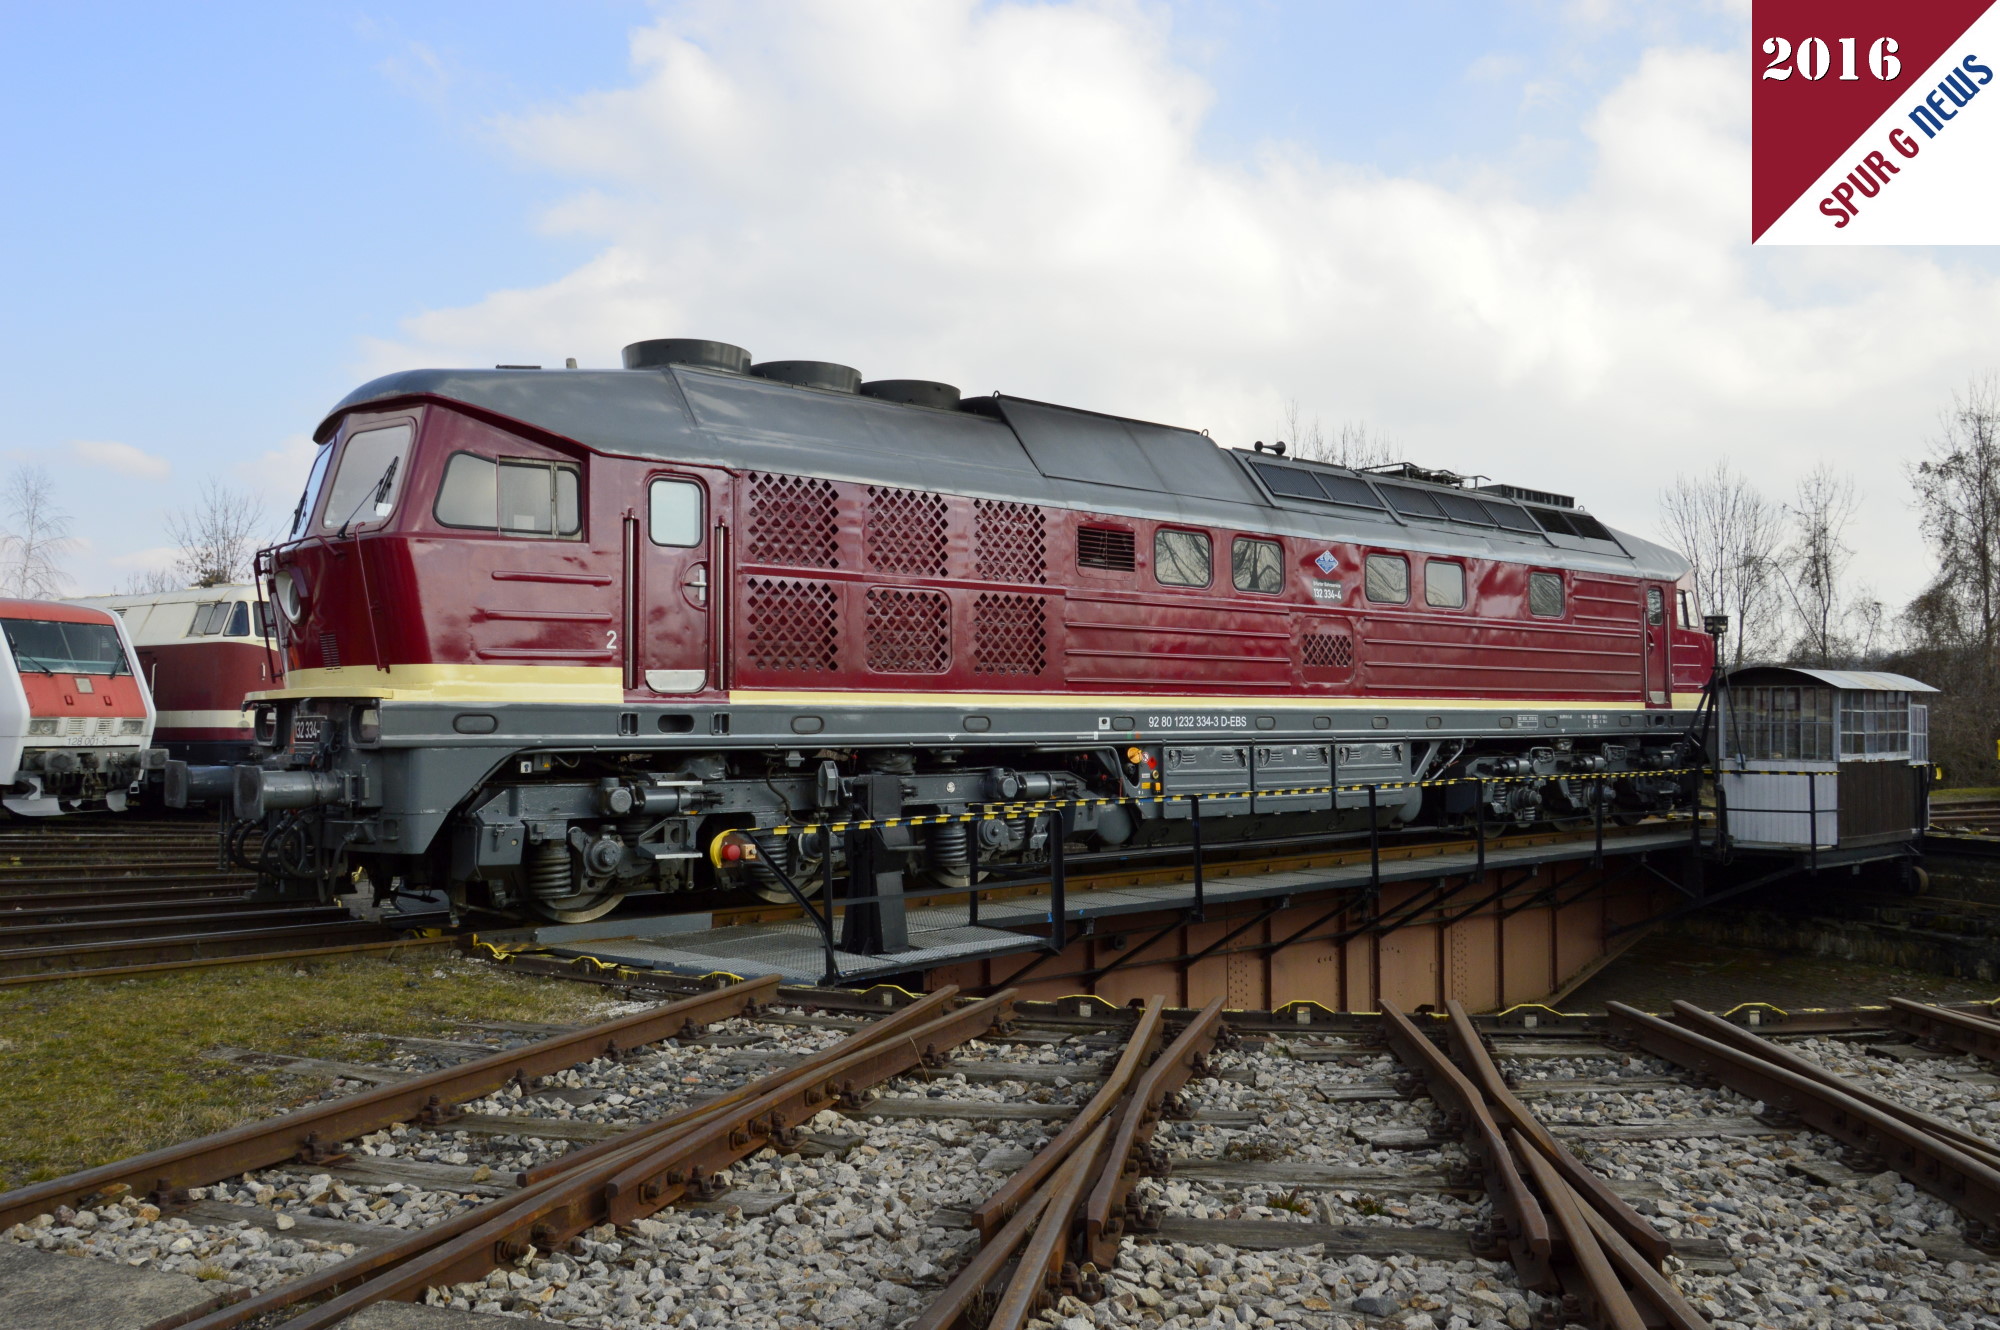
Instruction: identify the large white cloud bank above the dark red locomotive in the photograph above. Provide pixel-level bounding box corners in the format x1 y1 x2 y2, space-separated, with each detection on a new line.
364 0 1996 612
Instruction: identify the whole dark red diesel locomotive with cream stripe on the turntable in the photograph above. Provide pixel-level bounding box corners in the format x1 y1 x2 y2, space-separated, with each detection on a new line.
188 340 1712 920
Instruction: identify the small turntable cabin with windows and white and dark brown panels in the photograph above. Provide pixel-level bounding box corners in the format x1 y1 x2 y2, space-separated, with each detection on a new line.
1716 666 1936 852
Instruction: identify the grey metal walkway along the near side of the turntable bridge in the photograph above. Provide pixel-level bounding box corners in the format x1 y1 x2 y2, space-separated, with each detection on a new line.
540 828 1688 984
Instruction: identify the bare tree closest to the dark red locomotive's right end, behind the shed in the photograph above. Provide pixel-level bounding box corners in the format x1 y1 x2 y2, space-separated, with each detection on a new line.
1660 462 1780 666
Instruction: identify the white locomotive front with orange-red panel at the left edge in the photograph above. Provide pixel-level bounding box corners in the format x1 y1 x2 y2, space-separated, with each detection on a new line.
0 600 164 816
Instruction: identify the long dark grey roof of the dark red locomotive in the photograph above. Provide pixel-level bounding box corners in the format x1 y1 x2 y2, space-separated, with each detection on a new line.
316 364 1688 580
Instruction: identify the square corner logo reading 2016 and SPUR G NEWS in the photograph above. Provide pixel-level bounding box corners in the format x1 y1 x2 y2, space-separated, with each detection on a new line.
1750 0 2000 244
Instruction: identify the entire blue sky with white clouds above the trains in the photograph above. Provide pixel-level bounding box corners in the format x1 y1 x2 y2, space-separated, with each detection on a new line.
0 0 2000 608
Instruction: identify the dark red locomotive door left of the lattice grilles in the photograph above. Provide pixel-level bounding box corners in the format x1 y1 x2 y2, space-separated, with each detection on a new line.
630 476 722 694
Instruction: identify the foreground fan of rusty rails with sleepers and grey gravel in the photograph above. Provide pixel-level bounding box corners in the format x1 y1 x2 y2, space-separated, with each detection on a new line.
0 980 2000 1330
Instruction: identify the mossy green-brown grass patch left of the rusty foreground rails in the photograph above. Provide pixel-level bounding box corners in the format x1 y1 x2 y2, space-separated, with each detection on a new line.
0 952 602 1190
